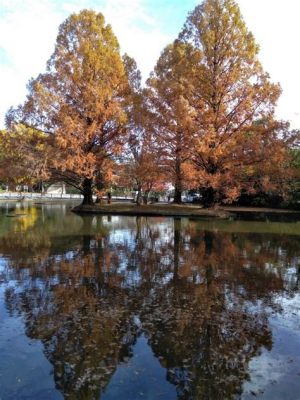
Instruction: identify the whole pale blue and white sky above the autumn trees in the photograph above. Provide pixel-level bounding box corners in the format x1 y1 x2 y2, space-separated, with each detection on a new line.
0 0 300 128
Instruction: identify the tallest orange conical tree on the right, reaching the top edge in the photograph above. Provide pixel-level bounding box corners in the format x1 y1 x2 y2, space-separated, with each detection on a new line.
180 0 293 205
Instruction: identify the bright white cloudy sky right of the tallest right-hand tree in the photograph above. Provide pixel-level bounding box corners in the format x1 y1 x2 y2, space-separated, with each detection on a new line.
238 0 300 128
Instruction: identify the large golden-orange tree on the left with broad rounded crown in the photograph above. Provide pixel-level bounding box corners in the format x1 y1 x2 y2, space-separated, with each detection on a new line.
7 10 128 204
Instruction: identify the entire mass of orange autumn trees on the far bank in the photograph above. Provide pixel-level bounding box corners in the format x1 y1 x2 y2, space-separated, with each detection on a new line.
0 0 299 206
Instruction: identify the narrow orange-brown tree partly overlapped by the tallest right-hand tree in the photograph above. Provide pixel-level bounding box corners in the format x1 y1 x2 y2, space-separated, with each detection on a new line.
147 41 195 203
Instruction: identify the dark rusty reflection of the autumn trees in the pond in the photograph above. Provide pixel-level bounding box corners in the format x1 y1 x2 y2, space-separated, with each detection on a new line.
0 206 299 399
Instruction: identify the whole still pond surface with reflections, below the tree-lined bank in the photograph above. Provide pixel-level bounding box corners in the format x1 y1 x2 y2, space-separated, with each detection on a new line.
0 202 300 400
